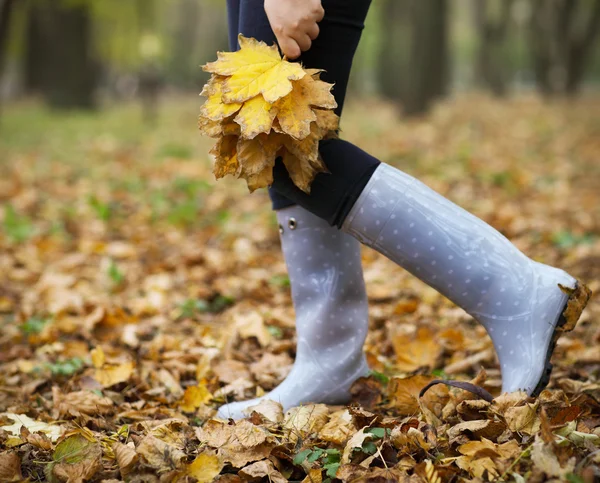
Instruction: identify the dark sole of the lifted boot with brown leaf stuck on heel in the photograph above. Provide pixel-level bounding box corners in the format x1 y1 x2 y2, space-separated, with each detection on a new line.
531 281 592 397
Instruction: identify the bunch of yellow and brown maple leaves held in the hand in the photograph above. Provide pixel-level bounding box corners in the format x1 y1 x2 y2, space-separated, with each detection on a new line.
198 35 339 193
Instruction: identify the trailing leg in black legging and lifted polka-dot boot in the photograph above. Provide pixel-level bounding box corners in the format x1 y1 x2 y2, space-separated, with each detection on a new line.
232 0 589 395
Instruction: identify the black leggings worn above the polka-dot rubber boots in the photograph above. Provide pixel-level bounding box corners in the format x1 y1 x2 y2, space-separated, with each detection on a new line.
227 0 379 227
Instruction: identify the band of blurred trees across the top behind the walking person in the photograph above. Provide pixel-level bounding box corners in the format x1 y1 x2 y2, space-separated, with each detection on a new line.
0 0 600 118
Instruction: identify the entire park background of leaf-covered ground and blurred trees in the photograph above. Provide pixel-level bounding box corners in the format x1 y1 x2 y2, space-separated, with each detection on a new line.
0 0 600 483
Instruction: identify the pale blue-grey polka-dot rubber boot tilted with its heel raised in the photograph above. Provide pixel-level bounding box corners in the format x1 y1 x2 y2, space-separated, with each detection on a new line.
342 164 577 395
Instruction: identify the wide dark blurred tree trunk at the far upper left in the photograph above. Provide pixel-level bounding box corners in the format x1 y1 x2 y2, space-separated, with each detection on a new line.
25 0 98 109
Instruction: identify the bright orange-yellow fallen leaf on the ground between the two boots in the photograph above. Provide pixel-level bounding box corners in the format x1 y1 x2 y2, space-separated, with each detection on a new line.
392 326 442 372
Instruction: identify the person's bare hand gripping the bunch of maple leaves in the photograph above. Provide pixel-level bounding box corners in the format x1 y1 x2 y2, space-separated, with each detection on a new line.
265 0 325 59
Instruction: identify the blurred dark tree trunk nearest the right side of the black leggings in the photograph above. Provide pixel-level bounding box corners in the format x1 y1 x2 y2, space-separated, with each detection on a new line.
403 0 449 116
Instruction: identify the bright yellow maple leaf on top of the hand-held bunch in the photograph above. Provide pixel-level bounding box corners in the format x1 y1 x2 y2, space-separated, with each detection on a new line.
204 35 306 104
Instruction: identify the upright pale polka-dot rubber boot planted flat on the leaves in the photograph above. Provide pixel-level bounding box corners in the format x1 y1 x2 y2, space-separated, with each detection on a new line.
217 206 369 419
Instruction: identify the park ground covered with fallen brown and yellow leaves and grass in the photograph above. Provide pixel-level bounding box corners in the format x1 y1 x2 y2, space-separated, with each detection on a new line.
0 96 600 482
